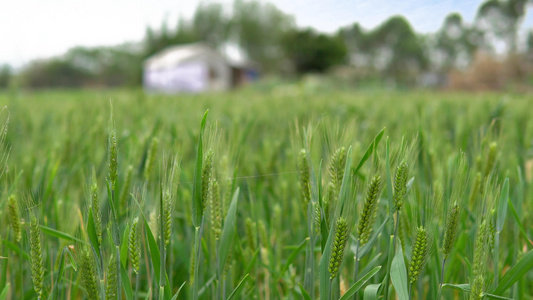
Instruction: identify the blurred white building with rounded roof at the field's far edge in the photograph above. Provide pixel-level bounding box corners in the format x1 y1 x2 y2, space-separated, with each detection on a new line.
143 43 257 93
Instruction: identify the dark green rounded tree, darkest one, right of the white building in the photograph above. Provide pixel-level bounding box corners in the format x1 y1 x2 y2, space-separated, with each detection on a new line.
283 29 346 74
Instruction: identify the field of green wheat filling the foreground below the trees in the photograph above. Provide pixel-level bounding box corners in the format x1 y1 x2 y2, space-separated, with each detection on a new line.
0 86 533 300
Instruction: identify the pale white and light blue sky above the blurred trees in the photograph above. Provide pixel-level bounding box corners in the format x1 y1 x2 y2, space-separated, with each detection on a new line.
0 0 533 67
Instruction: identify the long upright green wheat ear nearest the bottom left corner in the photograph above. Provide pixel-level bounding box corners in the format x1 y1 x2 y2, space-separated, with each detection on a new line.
30 215 44 298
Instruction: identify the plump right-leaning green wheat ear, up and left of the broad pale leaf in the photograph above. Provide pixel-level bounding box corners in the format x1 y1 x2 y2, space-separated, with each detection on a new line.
357 175 381 246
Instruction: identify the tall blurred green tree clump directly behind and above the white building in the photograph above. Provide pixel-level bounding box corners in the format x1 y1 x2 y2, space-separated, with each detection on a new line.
144 0 294 71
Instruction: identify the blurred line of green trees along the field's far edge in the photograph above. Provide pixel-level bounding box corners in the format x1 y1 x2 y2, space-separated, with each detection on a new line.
0 0 533 88
